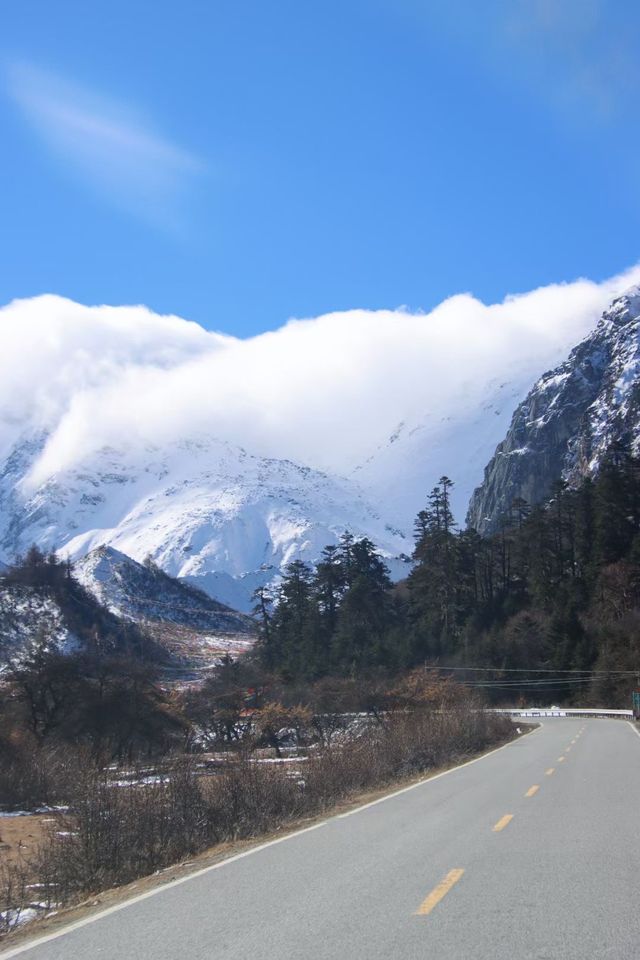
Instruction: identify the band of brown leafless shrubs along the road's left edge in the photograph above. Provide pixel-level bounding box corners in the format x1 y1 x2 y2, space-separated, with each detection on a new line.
5 705 512 928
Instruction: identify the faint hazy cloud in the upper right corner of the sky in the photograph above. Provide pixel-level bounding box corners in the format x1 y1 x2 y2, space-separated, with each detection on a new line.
402 0 640 125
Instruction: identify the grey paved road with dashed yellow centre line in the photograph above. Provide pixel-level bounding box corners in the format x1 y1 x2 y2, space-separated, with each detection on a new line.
5 719 640 960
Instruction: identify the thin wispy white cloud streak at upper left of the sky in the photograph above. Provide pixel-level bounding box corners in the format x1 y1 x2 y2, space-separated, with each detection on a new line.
7 63 204 227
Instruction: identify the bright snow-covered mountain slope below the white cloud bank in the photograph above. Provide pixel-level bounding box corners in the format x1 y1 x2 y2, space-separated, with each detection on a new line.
0 434 411 612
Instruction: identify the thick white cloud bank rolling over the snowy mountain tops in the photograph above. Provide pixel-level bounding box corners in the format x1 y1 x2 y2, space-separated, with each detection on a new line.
0 266 640 498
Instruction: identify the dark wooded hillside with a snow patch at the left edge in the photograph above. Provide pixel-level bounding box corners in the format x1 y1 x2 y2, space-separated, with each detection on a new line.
0 547 188 764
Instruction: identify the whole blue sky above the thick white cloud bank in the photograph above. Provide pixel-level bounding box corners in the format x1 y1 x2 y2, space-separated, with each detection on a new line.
0 0 640 336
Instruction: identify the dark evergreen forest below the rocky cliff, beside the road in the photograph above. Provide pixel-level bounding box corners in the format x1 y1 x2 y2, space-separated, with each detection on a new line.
257 446 640 706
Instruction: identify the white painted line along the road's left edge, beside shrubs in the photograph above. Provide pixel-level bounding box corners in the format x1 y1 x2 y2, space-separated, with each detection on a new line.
0 723 540 960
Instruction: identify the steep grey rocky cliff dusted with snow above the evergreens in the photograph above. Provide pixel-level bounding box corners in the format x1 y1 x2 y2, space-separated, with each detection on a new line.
467 287 640 533
